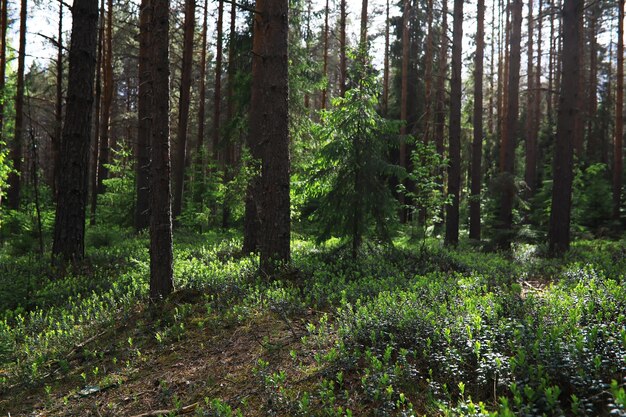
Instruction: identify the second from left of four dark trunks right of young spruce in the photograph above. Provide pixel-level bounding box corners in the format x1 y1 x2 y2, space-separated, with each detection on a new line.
469 0 485 240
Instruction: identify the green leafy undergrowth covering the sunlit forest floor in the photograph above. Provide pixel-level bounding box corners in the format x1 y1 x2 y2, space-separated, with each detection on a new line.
0 231 626 416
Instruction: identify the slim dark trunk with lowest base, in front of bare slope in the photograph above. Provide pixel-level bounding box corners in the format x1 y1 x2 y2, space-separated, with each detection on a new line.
149 0 174 300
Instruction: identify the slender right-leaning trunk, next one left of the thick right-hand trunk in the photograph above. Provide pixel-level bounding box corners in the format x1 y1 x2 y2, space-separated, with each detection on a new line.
500 0 522 244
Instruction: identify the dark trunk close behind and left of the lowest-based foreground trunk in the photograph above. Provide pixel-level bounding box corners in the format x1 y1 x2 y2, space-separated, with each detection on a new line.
135 0 153 231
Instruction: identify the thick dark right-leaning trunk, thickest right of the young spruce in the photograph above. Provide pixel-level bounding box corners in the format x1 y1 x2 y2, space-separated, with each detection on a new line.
548 0 580 255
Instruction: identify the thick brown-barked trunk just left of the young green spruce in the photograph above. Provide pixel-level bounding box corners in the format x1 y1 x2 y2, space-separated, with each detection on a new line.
250 0 291 274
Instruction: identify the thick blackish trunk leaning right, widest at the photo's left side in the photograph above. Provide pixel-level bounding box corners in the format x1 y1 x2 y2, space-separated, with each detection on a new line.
52 0 98 261
